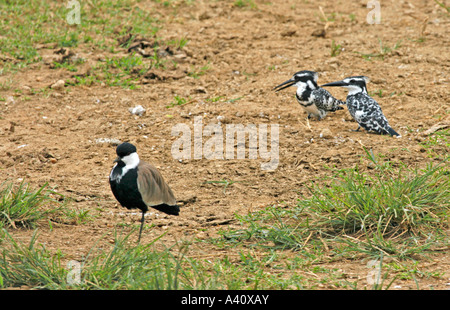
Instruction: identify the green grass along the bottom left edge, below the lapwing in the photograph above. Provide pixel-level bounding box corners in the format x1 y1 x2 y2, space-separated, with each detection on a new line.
0 230 218 290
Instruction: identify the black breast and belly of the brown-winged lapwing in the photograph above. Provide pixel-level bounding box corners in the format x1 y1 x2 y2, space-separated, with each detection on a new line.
109 165 148 212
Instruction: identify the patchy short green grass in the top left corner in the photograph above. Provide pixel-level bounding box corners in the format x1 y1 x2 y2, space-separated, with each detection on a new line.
0 0 187 89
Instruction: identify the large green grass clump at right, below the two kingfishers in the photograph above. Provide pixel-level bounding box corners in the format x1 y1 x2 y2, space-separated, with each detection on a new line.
217 151 450 259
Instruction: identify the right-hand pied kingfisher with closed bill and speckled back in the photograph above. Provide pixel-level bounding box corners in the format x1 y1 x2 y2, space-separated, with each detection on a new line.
322 76 401 138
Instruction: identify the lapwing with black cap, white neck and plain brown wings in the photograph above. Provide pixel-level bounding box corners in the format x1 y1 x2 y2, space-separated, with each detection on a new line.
109 142 180 242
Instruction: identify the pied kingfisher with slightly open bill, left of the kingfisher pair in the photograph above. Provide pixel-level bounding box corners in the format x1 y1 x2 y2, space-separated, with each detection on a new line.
274 70 345 120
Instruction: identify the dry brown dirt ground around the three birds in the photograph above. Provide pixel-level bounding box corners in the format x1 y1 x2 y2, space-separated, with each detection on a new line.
0 0 450 289
